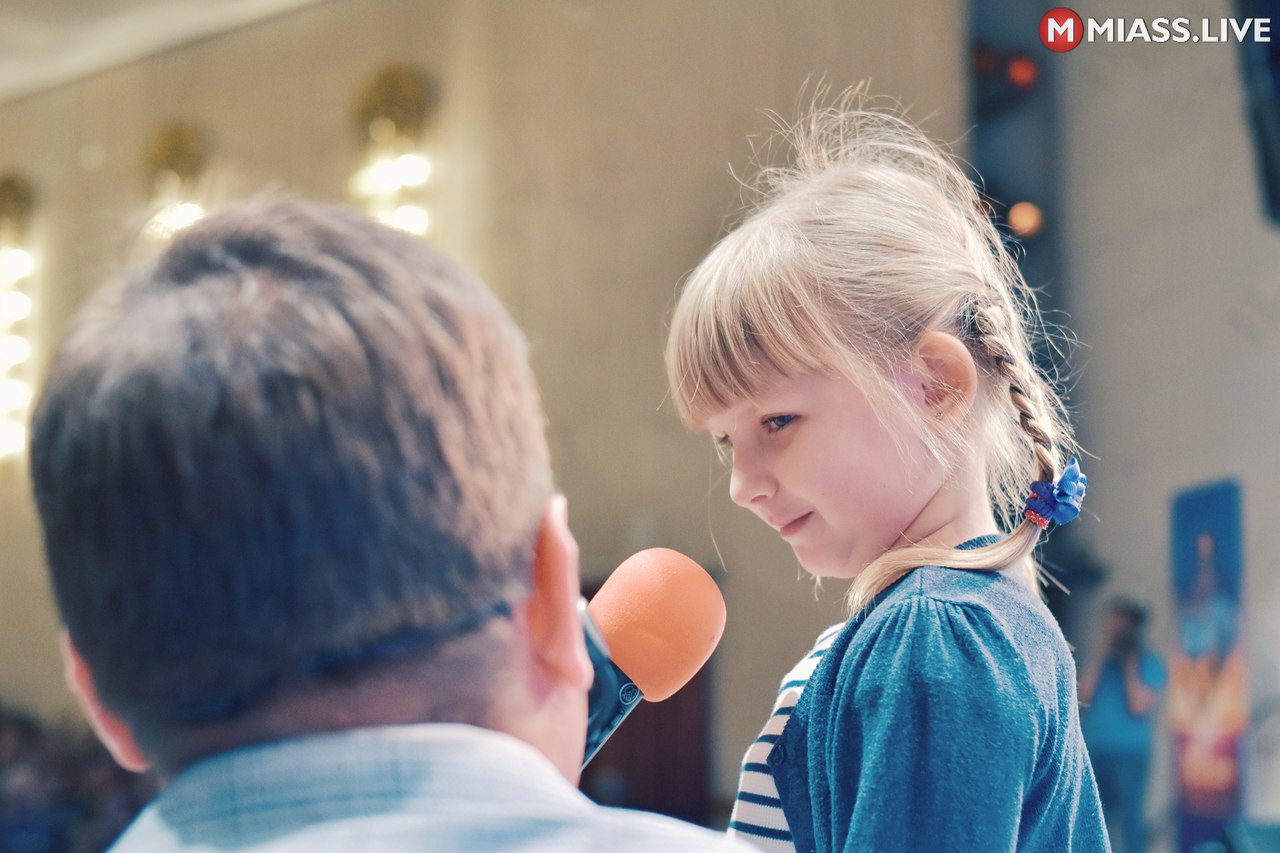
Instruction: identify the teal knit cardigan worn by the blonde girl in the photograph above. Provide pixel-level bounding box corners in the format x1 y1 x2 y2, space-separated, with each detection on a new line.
769 542 1110 853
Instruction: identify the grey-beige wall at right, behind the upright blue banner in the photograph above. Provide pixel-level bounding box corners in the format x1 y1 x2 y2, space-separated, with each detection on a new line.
1057 0 1280 824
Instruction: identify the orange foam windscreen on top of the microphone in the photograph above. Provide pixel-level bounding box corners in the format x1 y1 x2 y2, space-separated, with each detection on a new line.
588 548 724 702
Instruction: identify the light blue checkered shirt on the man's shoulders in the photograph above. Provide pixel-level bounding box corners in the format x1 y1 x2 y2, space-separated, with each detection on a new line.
111 724 750 853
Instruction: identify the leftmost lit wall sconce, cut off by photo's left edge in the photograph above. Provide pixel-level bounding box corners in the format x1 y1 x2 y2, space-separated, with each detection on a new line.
0 174 36 461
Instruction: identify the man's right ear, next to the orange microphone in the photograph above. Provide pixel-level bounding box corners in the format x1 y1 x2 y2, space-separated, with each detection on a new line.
525 494 593 694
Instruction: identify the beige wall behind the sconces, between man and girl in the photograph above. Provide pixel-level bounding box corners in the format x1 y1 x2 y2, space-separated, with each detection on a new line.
0 0 968 795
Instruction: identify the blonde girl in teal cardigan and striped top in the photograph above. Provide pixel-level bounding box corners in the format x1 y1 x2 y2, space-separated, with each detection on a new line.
667 93 1108 852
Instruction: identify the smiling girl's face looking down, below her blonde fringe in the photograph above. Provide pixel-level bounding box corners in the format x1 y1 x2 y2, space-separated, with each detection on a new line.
704 371 946 578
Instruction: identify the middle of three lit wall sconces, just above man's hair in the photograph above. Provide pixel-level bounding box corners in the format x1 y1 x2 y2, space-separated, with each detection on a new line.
142 123 209 243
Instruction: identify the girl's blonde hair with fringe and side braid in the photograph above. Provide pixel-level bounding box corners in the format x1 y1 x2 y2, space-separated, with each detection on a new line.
667 90 1074 612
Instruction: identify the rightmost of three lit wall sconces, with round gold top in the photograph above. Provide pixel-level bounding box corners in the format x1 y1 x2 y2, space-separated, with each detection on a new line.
351 65 439 234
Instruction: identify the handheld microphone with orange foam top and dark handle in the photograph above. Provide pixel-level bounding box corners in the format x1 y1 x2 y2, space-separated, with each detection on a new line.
579 548 724 767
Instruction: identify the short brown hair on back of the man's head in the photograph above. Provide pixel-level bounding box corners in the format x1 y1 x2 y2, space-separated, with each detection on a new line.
31 201 580 778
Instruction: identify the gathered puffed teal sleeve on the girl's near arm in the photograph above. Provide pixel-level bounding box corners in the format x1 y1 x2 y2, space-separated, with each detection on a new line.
813 596 1044 853
